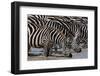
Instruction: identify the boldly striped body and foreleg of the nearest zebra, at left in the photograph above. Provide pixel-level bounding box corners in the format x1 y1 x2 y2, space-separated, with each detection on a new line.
28 15 72 56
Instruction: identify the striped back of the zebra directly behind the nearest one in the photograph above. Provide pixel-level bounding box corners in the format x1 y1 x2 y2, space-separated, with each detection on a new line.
28 15 69 50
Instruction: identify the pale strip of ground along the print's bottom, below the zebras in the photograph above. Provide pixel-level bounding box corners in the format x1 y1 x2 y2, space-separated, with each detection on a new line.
28 49 88 61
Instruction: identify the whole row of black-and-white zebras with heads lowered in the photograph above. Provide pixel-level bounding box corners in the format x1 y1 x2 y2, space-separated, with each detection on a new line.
27 14 88 57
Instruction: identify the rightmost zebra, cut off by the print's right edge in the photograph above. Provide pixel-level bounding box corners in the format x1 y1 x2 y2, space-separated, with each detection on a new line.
67 17 88 48
